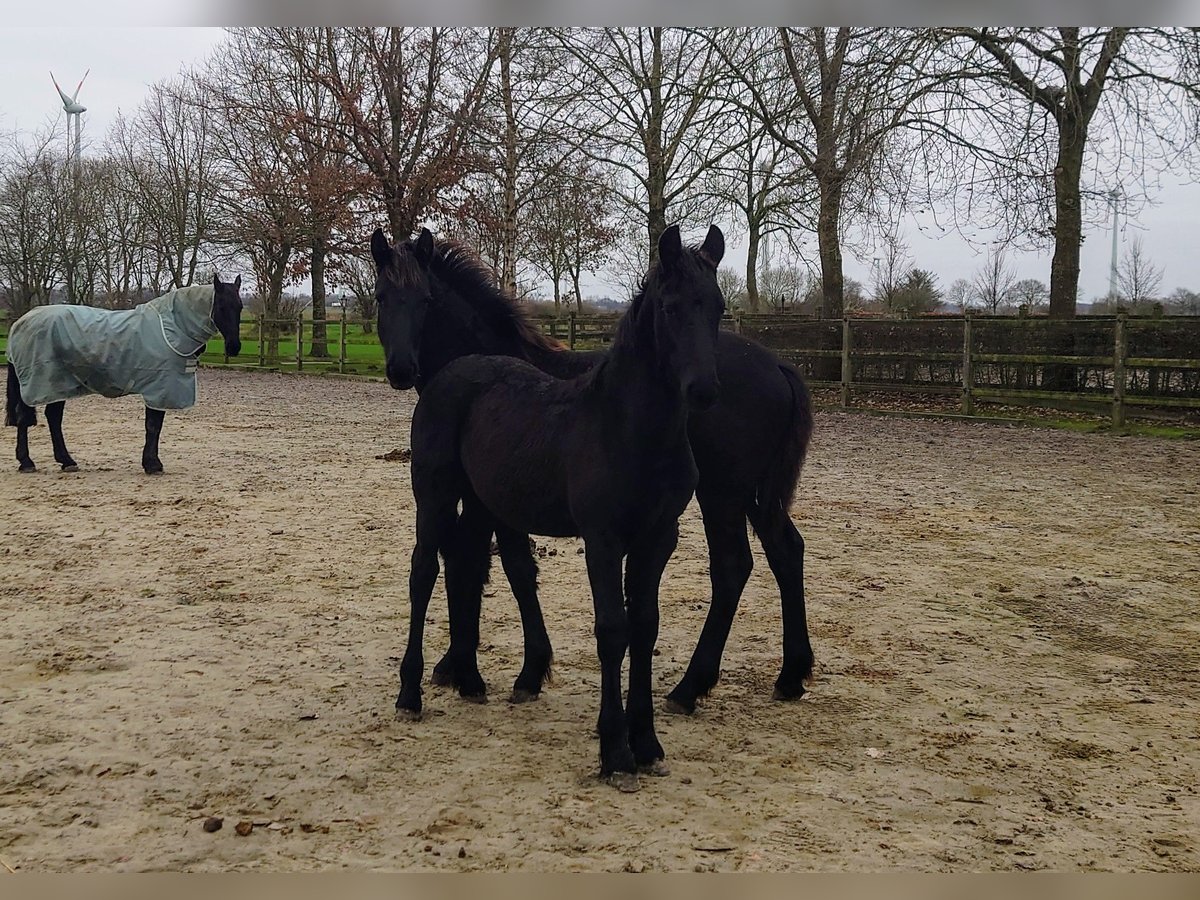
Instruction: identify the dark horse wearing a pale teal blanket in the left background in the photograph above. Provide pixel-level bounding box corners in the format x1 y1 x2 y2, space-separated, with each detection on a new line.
5 275 241 475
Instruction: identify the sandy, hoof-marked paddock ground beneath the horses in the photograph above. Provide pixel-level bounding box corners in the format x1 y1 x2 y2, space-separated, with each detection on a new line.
0 371 1200 880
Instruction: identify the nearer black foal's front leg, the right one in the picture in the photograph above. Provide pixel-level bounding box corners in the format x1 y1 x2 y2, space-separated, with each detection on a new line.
625 520 679 775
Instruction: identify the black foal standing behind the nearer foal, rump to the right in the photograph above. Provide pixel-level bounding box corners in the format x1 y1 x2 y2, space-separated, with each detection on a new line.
371 230 812 713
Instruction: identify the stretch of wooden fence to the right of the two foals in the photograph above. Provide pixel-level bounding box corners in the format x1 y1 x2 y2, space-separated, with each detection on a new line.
734 313 1200 427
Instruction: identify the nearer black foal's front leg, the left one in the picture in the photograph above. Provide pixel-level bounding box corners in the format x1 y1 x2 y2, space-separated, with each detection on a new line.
583 534 637 791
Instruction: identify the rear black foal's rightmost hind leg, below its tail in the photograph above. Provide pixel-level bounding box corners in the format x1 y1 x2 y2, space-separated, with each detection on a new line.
750 506 812 700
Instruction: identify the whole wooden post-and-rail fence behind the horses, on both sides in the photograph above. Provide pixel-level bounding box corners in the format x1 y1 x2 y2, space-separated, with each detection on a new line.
0 308 1200 427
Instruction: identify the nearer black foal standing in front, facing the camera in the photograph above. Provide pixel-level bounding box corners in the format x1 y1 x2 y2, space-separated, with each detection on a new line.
398 226 725 790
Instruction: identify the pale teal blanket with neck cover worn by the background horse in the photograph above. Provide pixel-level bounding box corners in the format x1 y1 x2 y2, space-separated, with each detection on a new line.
7 284 217 409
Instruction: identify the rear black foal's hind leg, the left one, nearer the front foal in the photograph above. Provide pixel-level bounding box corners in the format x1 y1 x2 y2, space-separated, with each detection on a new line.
664 485 754 715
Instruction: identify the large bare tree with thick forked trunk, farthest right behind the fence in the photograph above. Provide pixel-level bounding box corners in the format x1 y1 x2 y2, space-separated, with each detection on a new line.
936 26 1200 318
